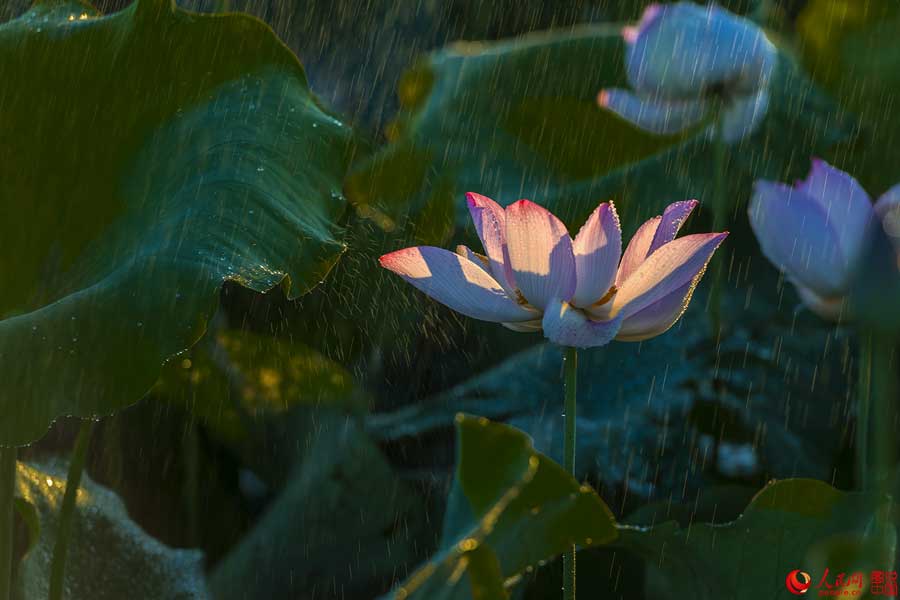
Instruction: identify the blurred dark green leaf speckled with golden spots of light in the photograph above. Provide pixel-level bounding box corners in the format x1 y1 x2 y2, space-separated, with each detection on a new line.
153 329 368 483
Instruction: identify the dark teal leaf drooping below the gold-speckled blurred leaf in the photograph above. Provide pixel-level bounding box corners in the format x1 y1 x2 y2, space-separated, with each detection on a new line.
210 409 433 600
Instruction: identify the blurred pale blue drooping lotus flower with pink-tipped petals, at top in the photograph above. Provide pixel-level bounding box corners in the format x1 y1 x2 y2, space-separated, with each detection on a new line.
598 2 777 143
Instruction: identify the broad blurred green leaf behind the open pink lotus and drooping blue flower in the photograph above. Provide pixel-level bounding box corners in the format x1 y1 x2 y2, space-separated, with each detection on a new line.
347 25 849 240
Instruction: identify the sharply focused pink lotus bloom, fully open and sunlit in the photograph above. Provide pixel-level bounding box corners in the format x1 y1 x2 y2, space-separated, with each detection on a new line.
380 193 727 348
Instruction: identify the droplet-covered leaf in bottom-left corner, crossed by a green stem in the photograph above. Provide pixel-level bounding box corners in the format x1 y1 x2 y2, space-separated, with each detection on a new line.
15 462 209 600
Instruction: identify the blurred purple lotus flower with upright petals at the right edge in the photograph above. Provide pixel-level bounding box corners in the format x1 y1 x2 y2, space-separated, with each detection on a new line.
749 158 900 319
